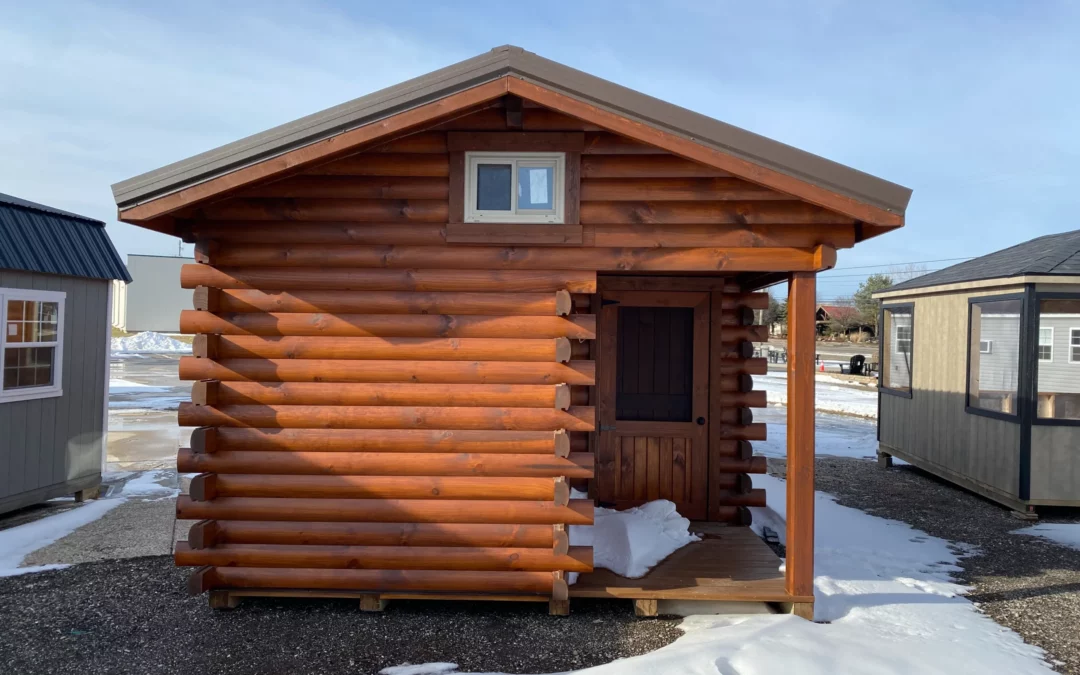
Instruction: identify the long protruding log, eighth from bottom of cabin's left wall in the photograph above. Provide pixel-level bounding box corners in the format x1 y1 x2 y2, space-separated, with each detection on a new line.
177 402 595 431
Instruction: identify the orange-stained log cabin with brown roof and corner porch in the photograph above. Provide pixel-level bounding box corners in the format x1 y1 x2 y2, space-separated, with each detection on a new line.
113 46 910 617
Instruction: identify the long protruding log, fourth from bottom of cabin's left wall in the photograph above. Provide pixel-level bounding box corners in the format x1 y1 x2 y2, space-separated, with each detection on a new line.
176 495 593 525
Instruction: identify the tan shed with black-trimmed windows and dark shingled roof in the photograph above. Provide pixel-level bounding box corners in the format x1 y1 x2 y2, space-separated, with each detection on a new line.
874 230 1080 513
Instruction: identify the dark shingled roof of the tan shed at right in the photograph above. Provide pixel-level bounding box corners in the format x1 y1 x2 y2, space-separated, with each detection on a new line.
882 230 1080 293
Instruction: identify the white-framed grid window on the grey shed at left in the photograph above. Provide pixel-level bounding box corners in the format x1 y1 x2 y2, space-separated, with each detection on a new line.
0 288 67 403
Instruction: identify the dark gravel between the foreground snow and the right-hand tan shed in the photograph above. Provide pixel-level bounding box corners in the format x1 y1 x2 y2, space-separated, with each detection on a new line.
769 457 1080 674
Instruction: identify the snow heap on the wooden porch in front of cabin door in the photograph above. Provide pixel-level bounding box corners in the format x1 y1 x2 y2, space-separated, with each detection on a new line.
570 497 699 579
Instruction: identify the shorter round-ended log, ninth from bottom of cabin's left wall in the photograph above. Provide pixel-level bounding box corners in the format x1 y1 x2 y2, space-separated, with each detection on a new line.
203 382 574 409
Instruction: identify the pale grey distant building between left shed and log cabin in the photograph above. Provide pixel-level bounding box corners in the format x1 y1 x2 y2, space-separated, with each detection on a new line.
112 255 194 333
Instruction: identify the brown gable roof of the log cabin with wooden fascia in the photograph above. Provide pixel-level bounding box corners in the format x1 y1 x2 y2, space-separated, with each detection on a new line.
112 45 912 225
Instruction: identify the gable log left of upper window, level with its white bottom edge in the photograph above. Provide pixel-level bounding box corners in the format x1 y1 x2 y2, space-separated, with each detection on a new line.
197 198 449 224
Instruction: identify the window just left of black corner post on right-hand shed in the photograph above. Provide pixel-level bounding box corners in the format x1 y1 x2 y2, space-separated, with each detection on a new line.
968 300 1021 415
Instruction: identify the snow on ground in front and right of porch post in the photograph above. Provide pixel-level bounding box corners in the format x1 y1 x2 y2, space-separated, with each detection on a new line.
382 476 1053 675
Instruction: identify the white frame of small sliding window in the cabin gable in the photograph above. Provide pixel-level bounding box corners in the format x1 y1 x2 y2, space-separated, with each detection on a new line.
464 152 566 225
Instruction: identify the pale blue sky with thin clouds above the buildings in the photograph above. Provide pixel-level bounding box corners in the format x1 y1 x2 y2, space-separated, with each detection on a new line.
0 0 1080 298
